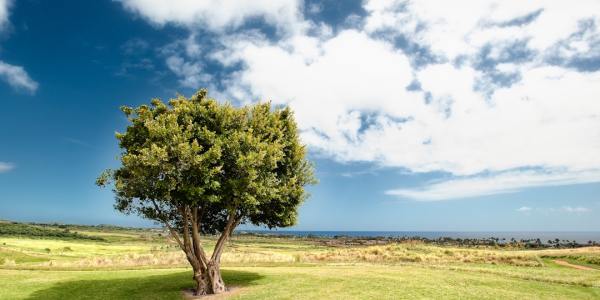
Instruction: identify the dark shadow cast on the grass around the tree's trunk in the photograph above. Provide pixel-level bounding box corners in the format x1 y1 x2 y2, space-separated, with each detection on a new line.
28 270 263 300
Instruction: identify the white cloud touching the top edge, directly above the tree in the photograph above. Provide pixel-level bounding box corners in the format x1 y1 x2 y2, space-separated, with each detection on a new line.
120 0 302 31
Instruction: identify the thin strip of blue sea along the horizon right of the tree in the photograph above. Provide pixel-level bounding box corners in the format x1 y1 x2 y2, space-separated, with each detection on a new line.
238 230 600 244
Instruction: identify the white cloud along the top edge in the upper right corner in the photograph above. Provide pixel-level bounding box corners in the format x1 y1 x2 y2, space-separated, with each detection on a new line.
365 0 600 59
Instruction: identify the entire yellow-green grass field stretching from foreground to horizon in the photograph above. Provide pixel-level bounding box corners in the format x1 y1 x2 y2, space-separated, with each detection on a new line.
0 223 600 299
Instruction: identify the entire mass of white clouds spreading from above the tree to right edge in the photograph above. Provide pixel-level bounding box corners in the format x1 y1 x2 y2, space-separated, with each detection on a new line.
123 0 600 201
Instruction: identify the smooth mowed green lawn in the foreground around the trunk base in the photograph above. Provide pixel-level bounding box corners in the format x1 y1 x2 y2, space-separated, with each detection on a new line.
0 265 600 299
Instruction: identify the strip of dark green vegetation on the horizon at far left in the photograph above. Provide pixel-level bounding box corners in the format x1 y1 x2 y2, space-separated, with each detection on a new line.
0 223 104 241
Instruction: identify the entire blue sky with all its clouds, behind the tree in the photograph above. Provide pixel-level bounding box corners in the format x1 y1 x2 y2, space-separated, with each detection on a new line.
0 0 600 231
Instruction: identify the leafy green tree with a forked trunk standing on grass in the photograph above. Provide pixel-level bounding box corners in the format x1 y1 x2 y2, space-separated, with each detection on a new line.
97 90 315 295
